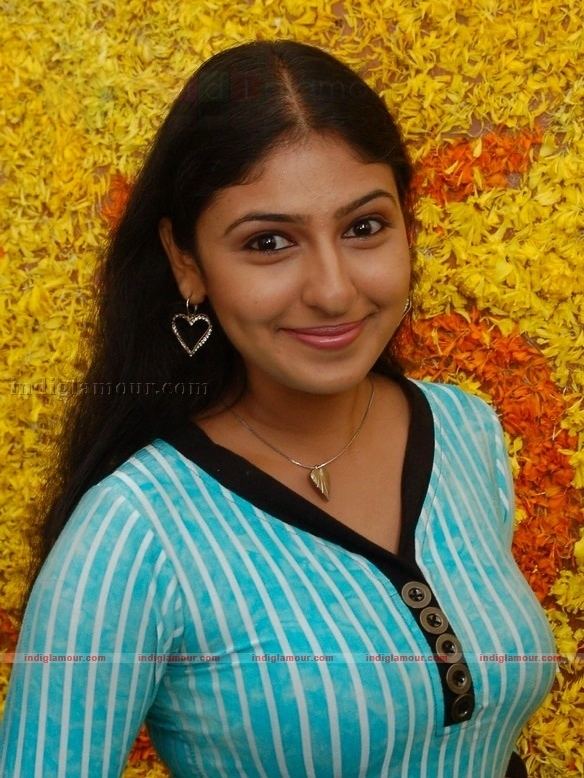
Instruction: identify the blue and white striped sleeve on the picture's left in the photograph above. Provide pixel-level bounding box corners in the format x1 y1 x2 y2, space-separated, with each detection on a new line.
0 477 182 778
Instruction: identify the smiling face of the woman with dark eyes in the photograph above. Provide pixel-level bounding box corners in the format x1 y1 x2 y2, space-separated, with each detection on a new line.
163 135 410 394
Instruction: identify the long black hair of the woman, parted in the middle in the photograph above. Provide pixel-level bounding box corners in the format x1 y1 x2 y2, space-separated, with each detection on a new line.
20 40 413 618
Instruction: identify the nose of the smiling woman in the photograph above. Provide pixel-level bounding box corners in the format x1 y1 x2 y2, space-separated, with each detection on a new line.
302 245 357 316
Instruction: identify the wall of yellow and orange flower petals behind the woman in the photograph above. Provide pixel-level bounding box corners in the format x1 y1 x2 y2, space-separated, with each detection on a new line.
0 0 584 778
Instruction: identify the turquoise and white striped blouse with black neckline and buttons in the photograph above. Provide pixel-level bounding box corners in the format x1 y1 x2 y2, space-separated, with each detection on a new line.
0 378 556 778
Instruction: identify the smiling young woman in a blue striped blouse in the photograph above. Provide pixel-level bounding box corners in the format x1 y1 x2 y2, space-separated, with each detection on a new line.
0 41 555 778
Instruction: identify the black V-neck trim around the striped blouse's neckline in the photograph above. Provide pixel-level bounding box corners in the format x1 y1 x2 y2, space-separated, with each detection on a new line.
155 365 434 580
